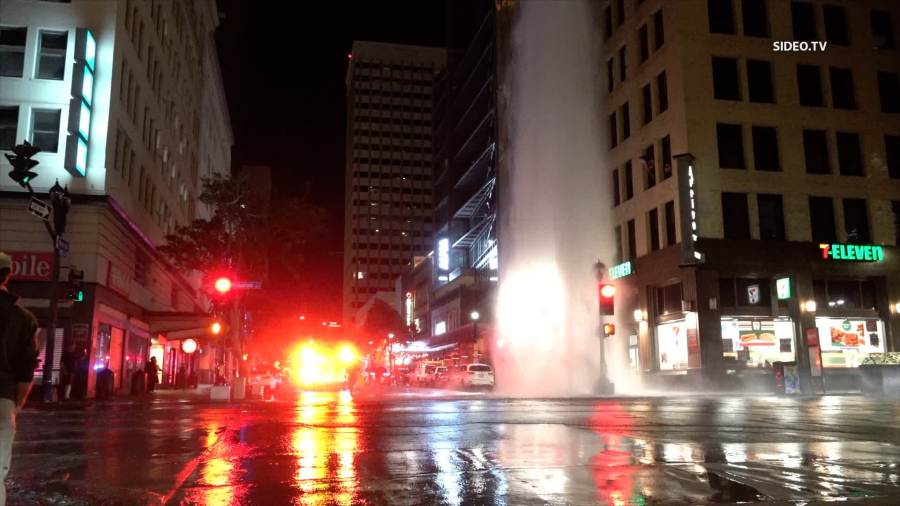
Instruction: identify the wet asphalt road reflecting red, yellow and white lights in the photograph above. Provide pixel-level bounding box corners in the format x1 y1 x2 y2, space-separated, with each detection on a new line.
7 392 900 505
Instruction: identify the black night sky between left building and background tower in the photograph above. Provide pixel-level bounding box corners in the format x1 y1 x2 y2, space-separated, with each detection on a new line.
217 0 447 319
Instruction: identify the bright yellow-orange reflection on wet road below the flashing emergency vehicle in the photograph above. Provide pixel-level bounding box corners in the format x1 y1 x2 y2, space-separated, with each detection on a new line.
291 392 359 506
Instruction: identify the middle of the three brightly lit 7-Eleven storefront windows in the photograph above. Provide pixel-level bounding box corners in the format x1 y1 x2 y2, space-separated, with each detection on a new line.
722 317 796 367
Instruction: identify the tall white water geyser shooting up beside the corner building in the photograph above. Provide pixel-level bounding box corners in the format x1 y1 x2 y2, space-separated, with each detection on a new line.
492 0 624 396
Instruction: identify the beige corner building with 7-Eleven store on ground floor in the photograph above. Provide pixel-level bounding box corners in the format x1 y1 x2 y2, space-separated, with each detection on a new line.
599 0 900 387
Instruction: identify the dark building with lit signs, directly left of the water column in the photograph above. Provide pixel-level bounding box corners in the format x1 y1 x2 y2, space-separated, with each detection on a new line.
428 1 499 359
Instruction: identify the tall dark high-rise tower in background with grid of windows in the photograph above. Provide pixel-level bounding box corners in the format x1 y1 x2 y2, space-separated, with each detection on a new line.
343 41 446 325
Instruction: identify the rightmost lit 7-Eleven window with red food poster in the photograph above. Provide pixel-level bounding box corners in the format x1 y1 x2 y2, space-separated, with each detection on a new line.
816 317 885 367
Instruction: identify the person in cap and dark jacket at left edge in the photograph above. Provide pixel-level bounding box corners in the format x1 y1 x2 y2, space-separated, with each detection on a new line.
0 252 38 506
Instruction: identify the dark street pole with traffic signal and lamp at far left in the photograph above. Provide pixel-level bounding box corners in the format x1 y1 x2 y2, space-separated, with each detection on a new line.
5 141 72 402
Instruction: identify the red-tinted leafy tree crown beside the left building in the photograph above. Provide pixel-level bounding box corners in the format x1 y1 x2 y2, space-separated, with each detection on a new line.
158 174 325 279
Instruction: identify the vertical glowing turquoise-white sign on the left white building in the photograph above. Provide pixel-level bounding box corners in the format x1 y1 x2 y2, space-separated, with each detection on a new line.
65 28 97 177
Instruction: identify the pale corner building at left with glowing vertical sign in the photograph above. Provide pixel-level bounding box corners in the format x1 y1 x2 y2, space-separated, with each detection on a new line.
0 0 232 395
